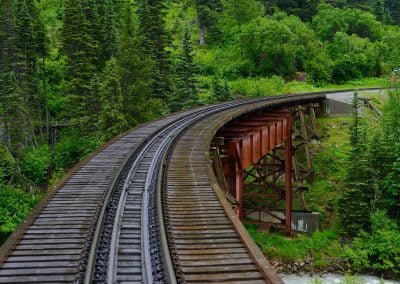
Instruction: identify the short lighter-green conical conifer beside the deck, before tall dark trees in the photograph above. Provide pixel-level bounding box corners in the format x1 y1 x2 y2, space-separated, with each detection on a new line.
99 58 128 139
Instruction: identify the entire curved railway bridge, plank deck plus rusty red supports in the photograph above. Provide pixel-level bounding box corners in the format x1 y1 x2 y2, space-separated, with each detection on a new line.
0 93 325 283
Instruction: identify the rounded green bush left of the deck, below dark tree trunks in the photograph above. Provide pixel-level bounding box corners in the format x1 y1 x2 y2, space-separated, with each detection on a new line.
20 145 50 185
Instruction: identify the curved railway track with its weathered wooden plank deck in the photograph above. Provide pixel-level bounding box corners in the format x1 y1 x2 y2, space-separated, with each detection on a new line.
0 94 324 283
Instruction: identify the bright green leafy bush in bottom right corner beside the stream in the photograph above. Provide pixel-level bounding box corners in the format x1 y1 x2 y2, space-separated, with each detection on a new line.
345 211 400 276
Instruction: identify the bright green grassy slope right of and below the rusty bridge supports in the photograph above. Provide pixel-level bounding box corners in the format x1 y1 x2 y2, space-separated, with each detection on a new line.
248 117 351 269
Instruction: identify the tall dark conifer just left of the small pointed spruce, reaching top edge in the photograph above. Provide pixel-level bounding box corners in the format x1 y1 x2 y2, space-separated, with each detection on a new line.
139 0 171 102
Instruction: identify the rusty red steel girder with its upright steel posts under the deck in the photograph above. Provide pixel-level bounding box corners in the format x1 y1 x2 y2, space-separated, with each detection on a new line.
214 110 293 234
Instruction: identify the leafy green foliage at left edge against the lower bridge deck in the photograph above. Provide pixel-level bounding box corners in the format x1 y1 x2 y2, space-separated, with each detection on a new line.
0 185 41 242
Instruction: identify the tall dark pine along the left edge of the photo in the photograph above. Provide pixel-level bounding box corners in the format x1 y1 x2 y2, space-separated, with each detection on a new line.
0 0 33 155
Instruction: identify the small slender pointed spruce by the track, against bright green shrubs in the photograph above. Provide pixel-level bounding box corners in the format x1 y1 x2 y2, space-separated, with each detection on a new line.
171 28 198 111
